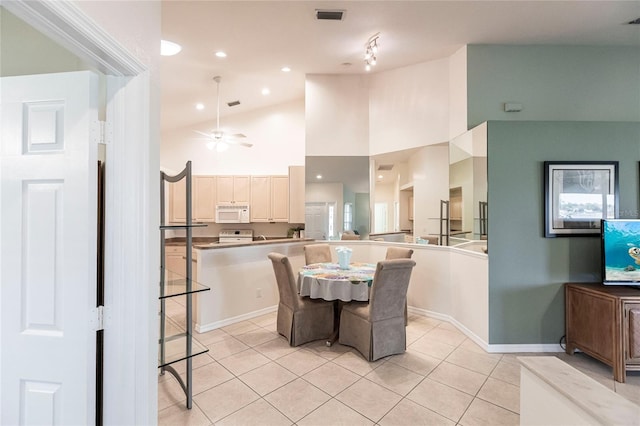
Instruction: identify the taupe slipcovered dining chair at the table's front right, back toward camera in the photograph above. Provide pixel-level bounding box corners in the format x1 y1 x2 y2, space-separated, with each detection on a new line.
339 259 416 361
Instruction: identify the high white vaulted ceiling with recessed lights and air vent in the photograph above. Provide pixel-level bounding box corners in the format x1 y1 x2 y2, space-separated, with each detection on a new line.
161 0 640 136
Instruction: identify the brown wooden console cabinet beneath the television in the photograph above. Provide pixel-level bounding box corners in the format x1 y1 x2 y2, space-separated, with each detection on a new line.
565 283 640 383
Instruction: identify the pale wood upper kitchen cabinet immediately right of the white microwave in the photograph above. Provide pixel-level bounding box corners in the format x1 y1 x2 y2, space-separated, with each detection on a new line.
251 176 289 222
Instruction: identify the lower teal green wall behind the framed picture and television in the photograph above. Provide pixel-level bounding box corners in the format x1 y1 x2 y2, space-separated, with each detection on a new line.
487 121 640 344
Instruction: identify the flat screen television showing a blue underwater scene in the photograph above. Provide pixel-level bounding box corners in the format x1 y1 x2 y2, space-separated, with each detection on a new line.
600 219 640 286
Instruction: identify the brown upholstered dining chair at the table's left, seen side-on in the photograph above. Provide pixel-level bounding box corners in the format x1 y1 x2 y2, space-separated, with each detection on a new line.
268 253 334 346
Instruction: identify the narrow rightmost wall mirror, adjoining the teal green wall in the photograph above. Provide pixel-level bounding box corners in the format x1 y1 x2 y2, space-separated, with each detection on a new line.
449 123 488 244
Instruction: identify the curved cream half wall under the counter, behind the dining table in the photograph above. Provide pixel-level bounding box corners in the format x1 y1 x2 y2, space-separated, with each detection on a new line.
194 239 490 351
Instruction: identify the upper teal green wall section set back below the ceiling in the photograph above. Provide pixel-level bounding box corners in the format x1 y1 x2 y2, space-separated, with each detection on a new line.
467 45 640 128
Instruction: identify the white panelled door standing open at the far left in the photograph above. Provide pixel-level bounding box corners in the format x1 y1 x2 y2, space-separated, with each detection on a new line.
0 71 98 425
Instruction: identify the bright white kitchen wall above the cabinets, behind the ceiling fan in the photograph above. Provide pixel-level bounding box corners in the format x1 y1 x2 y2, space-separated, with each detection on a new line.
161 99 305 175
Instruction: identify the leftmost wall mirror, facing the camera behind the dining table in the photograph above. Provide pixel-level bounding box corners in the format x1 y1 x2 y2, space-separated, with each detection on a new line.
305 156 370 240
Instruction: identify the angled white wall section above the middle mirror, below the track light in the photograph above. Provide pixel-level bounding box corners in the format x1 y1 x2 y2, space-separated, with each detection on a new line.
369 59 449 155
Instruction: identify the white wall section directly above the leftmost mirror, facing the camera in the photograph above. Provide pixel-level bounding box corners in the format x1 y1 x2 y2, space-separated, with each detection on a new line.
305 74 369 156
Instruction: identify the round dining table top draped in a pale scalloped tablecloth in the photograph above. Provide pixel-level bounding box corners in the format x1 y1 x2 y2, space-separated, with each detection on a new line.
298 262 376 302
